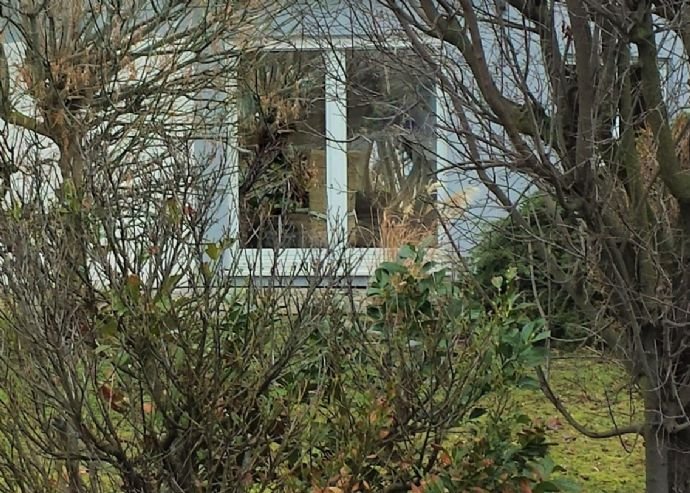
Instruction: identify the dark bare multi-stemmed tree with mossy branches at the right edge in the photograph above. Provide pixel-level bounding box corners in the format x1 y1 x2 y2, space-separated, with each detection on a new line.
353 0 690 493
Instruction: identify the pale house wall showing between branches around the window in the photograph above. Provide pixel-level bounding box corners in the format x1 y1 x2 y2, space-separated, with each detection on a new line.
0 0 690 272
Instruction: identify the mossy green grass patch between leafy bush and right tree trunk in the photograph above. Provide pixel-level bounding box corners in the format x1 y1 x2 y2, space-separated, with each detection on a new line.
518 351 644 493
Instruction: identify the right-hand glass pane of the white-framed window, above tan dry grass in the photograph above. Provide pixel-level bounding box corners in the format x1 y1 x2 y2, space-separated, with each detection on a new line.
347 51 437 248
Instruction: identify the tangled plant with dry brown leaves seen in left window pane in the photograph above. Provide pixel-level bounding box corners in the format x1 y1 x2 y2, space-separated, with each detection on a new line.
239 53 325 246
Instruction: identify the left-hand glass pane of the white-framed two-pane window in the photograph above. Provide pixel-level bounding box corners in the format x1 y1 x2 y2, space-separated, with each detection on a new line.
238 52 327 248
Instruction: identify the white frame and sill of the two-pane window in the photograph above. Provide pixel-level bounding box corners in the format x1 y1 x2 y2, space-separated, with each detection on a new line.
224 38 450 279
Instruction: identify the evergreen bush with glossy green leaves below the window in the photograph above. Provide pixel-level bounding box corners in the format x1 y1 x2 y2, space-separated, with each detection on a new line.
270 246 573 492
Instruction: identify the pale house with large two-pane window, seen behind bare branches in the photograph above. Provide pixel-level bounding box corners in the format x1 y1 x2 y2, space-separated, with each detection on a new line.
3 0 676 282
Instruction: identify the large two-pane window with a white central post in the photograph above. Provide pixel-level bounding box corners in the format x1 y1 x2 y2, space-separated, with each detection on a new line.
227 48 441 274
